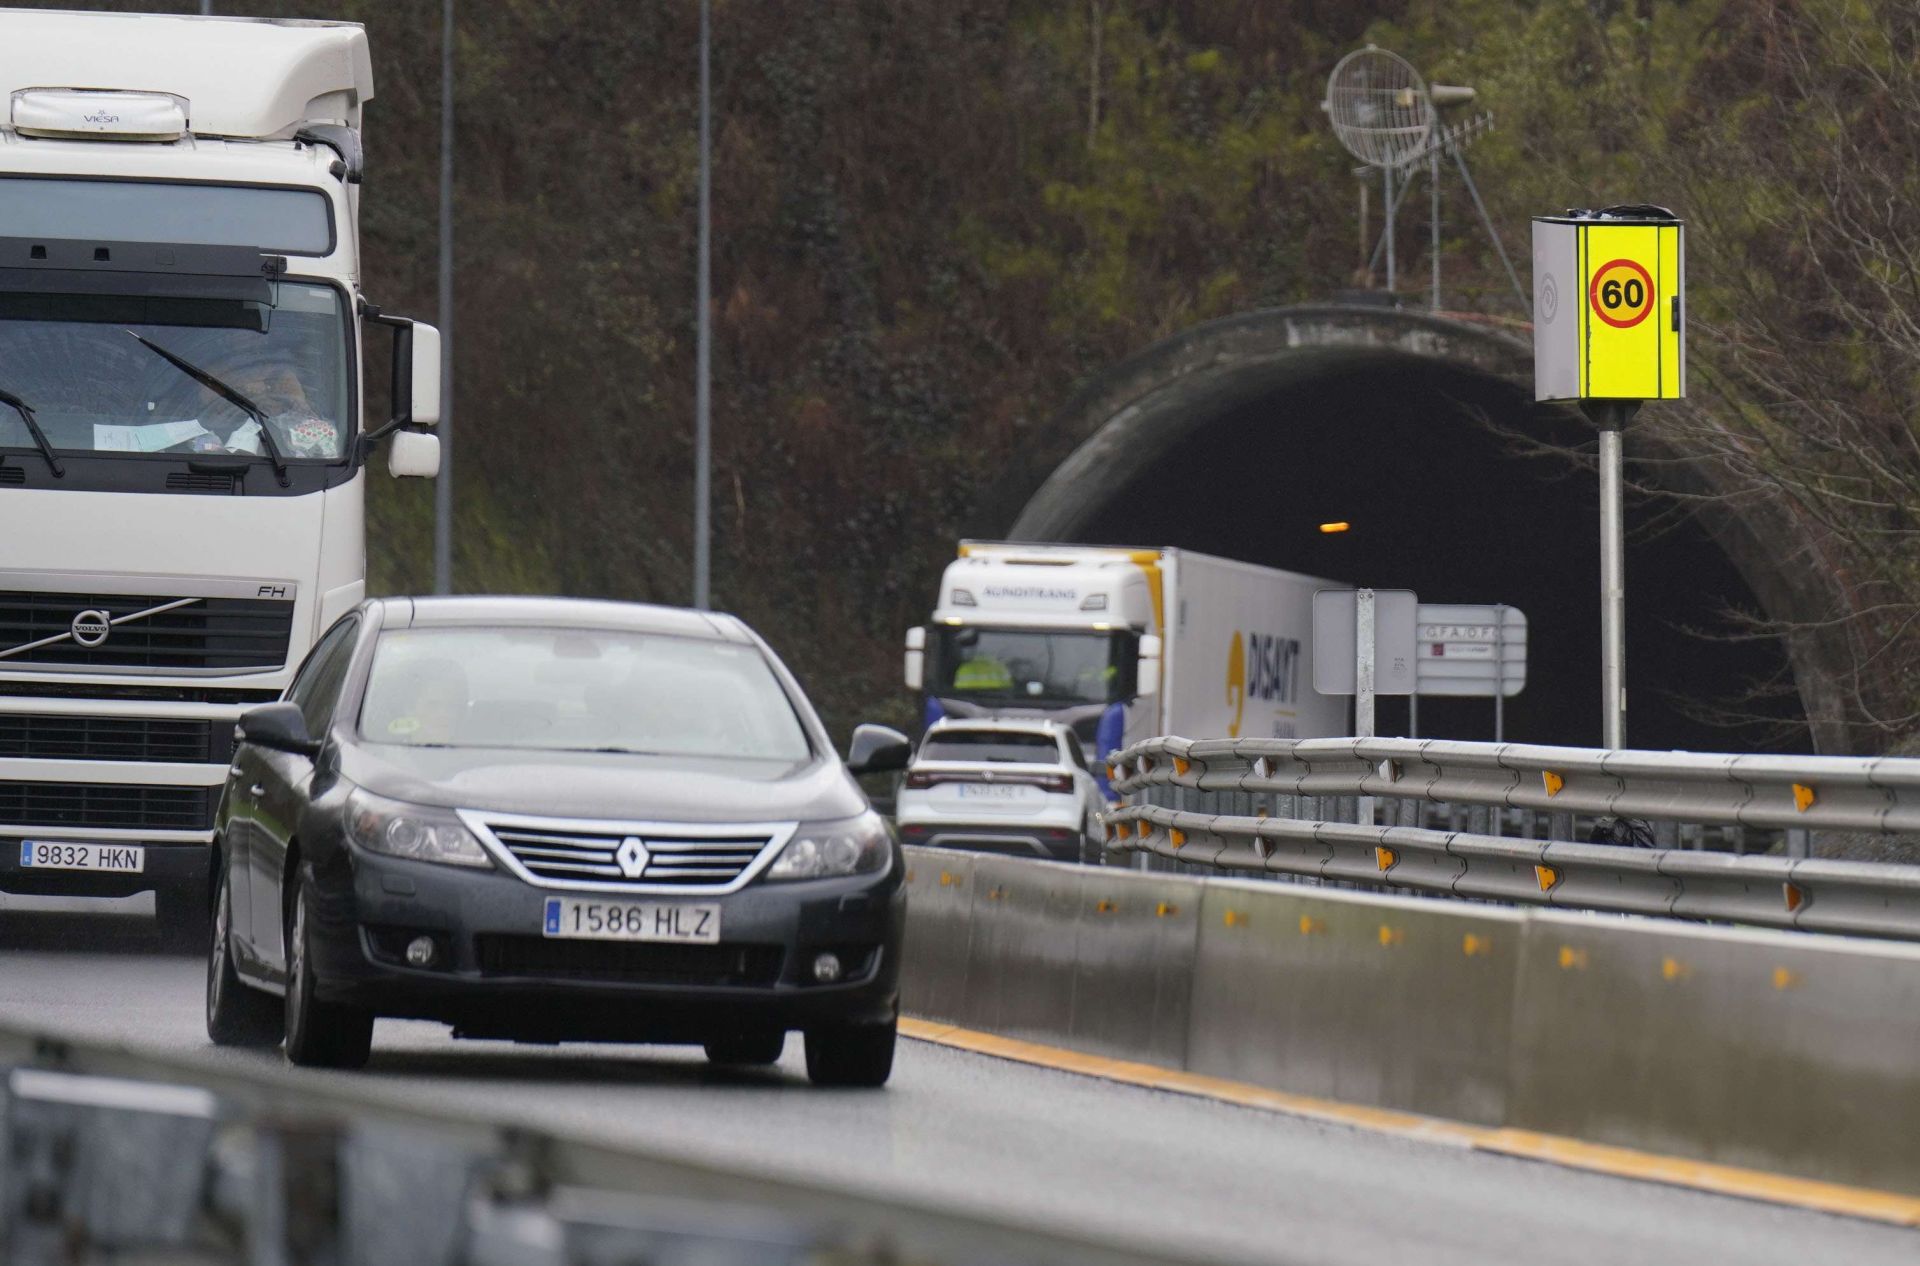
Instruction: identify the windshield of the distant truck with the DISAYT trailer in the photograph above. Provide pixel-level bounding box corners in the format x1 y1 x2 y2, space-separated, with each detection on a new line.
927 624 1137 707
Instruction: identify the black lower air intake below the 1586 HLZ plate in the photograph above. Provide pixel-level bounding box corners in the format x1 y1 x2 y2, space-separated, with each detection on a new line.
474 934 785 987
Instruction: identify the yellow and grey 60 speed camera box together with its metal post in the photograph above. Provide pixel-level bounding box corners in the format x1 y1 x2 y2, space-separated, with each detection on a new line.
1528 206 1686 749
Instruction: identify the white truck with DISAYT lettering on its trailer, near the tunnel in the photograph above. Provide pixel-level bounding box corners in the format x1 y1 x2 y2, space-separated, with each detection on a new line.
906 542 1348 793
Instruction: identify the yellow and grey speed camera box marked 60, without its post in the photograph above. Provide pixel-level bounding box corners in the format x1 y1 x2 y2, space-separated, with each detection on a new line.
1534 207 1686 400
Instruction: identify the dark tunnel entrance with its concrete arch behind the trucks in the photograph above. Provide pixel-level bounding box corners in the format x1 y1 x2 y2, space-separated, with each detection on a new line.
1000 305 1849 751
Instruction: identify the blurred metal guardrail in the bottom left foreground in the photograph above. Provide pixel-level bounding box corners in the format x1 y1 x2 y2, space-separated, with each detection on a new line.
0 1020 1167 1266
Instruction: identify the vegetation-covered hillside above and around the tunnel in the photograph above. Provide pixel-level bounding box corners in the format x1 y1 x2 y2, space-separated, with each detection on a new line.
26 0 1920 747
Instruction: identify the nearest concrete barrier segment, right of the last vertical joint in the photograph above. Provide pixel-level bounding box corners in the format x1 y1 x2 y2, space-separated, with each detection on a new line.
1509 914 1920 1193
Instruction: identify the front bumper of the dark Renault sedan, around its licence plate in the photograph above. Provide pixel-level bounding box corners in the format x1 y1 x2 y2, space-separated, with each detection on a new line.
313 849 906 1041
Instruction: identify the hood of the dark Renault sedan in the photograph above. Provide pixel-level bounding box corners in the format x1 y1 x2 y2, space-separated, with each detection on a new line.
340 743 866 822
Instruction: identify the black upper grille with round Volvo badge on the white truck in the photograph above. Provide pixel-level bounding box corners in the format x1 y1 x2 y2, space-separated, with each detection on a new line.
0 590 294 672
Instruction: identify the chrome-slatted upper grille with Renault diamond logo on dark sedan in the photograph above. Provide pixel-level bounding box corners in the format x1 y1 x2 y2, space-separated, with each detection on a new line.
488 822 776 888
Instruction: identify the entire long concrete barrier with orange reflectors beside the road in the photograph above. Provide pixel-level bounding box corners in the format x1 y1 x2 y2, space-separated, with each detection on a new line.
902 849 1920 1193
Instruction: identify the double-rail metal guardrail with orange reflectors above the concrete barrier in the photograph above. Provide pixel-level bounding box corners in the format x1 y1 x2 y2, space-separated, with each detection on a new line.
1106 738 1920 939
